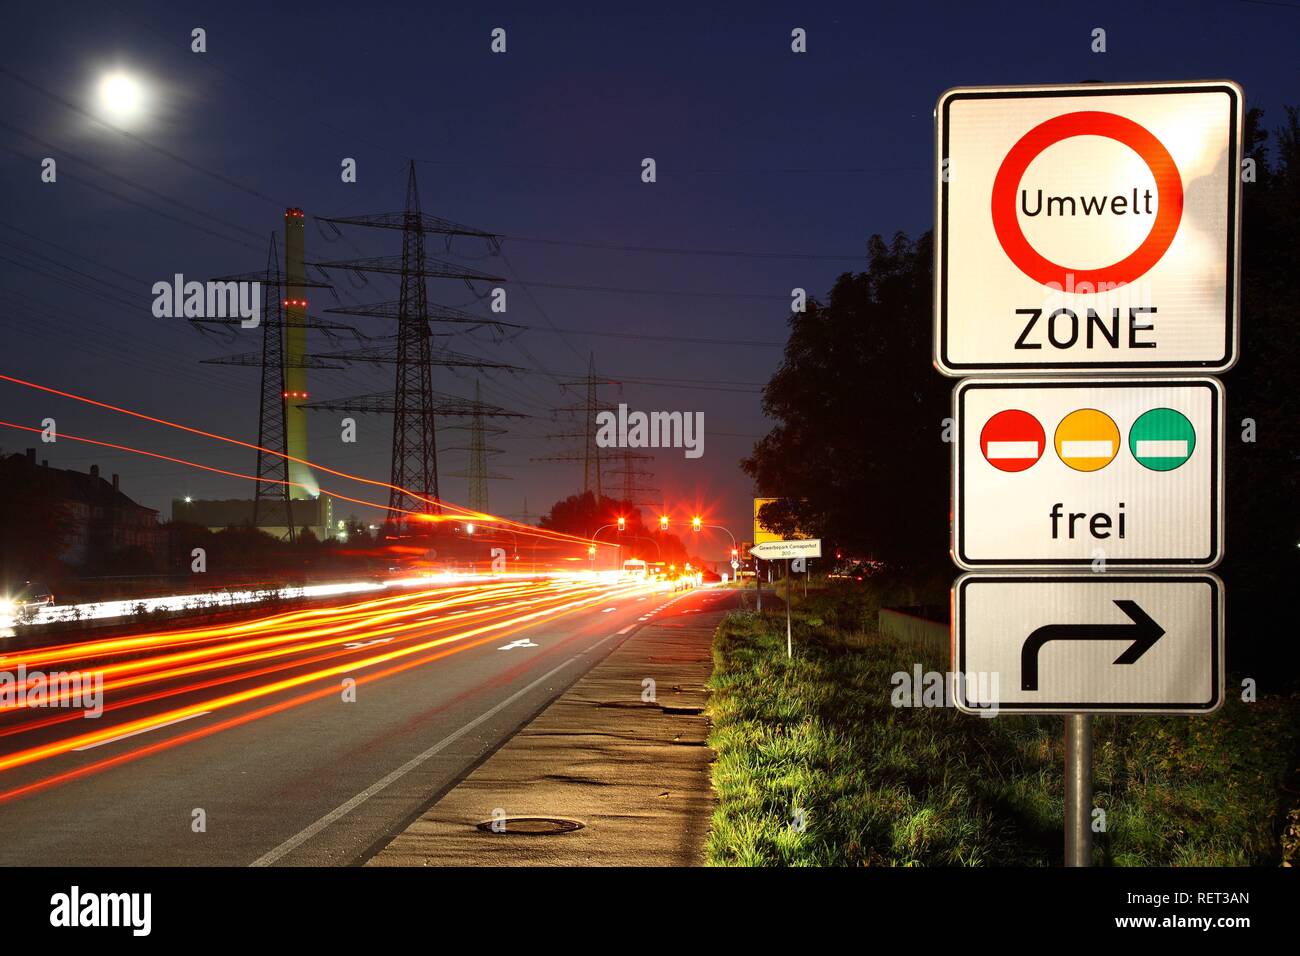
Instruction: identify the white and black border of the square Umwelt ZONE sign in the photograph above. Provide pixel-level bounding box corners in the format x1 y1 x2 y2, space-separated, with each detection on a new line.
932 79 1245 378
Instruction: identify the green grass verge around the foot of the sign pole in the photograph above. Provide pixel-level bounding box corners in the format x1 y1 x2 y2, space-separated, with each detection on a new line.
707 585 1300 866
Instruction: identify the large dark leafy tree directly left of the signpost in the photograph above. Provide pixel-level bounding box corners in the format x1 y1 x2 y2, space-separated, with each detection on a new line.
741 233 952 564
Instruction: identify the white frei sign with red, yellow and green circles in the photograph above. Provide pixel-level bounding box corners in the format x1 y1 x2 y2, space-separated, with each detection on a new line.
952 378 1223 570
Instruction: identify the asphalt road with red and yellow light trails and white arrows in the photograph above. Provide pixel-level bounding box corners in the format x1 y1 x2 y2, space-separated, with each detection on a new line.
0 575 706 866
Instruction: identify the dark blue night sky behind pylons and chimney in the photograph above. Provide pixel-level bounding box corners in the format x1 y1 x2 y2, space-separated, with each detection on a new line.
0 0 1300 548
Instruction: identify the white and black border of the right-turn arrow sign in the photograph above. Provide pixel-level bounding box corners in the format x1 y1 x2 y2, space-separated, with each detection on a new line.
950 571 1227 715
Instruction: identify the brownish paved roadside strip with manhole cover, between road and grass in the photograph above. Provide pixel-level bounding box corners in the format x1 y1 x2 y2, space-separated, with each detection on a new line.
367 591 735 866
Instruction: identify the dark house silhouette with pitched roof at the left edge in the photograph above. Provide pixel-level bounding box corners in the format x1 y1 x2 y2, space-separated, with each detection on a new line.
9 449 166 567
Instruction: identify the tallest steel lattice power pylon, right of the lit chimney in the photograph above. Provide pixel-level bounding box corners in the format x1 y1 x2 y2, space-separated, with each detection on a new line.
316 160 512 535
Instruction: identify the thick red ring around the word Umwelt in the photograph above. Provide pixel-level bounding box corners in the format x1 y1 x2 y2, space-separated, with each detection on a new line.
992 111 1183 289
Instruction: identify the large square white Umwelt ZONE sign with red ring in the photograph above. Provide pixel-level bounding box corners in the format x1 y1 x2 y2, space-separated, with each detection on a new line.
935 82 1243 376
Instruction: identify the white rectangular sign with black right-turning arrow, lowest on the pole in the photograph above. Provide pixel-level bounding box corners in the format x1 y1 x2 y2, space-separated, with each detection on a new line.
953 574 1223 714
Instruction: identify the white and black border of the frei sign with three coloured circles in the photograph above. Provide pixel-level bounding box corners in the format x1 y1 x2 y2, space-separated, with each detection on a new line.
948 376 1226 571
